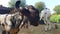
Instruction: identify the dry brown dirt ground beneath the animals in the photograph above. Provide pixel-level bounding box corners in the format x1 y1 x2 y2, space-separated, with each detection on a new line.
0 25 60 34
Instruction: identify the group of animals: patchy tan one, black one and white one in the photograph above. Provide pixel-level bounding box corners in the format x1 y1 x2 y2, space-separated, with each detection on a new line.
0 1 57 34
